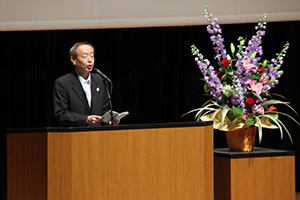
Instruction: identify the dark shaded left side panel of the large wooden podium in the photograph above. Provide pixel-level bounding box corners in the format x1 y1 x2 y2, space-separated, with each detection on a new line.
7 133 47 200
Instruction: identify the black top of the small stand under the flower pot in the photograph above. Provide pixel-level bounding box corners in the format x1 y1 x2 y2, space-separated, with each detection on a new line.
214 147 295 159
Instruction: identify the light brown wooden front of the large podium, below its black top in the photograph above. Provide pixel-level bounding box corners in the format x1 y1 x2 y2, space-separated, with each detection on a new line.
48 127 213 200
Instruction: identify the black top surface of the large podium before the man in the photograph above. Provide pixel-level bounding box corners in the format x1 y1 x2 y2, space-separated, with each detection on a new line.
6 121 213 134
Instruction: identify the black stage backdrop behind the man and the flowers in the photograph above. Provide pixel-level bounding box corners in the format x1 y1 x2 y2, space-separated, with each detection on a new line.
0 21 300 196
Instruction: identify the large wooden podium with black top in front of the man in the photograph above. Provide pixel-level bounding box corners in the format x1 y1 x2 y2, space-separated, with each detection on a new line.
7 122 214 200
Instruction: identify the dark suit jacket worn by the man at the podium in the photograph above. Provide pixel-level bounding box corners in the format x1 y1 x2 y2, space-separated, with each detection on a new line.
53 70 109 126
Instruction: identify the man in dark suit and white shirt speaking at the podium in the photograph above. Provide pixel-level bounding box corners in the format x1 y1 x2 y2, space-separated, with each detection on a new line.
53 42 109 126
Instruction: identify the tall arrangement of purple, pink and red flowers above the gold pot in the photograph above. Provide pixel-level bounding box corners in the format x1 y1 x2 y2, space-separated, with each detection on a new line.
188 6 300 142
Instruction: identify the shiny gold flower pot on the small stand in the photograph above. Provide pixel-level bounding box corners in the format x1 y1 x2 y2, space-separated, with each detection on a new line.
225 125 256 151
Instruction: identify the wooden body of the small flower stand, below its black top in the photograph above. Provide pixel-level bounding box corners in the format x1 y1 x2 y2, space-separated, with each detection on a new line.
215 156 296 200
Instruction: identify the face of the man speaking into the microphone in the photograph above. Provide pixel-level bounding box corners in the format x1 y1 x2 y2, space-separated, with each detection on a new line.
71 44 95 77
